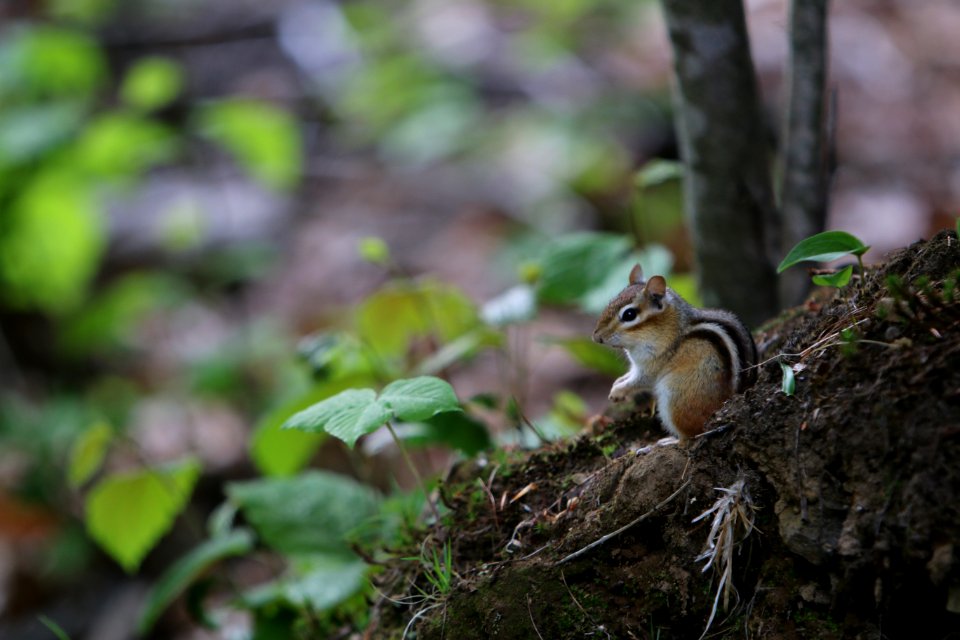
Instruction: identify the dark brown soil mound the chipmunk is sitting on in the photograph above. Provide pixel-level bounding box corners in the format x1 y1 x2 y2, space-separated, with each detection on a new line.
367 232 960 640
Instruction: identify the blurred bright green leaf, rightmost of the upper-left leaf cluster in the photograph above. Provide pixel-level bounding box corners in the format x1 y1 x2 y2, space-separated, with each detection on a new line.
200 99 302 190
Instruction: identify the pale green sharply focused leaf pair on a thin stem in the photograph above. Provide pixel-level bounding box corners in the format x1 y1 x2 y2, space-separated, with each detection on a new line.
283 376 460 447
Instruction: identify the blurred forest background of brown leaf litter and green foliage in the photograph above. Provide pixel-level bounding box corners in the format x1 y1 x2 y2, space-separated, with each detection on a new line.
0 0 960 640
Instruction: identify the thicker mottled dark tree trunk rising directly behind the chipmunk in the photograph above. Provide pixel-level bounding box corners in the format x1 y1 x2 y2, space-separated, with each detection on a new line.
663 0 780 326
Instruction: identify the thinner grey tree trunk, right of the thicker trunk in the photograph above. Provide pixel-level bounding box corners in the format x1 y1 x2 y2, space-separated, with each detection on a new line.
780 0 829 306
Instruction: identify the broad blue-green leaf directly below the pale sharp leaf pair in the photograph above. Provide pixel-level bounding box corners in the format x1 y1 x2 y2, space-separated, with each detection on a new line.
227 471 380 554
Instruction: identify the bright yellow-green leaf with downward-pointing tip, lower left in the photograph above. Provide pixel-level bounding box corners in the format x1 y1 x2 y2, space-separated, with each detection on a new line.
86 459 200 573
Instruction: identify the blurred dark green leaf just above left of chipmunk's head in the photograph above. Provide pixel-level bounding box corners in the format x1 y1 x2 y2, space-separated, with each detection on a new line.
537 233 630 303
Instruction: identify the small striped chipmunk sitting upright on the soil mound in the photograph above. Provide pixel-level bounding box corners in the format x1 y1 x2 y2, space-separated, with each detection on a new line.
593 264 757 440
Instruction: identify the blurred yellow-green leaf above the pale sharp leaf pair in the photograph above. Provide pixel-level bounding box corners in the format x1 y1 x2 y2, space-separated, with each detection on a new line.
357 281 479 361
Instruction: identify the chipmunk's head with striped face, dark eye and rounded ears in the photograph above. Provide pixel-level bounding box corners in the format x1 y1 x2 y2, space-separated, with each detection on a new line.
593 264 669 347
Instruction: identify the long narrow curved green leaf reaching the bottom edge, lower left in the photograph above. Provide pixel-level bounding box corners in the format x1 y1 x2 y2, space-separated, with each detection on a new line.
137 529 254 634
